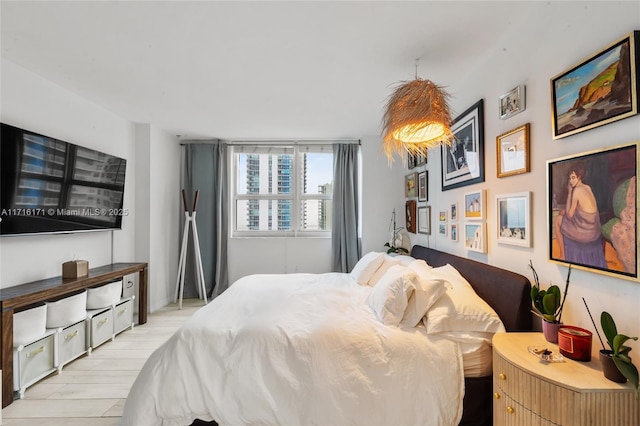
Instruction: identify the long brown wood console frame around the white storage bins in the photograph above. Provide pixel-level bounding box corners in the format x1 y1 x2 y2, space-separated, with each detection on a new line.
0 263 148 408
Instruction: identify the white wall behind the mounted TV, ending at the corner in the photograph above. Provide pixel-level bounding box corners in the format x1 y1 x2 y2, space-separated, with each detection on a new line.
0 59 135 288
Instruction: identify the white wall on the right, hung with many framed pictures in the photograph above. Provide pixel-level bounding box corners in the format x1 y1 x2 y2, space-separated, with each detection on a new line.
408 2 640 351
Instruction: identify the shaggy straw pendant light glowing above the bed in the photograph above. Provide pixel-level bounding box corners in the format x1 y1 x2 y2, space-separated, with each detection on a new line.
382 60 453 160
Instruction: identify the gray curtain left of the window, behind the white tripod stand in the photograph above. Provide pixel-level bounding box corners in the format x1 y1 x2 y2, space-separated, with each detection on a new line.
180 141 229 299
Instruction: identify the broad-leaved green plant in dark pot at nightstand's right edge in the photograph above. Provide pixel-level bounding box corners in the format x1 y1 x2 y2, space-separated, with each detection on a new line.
600 311 640 399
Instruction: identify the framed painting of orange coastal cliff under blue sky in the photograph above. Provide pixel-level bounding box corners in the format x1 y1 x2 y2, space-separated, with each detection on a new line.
551 31 640 139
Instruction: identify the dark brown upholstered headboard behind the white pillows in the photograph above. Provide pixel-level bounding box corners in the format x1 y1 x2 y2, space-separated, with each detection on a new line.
411 245 532 331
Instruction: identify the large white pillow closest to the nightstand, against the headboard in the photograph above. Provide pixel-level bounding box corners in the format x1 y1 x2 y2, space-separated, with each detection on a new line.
423 265 505 334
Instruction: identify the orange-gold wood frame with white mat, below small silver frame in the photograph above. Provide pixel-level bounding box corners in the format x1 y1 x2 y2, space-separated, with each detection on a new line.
496 123 531 178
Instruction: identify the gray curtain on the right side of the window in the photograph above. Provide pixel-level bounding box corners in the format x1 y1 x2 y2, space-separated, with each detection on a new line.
331 143 361 272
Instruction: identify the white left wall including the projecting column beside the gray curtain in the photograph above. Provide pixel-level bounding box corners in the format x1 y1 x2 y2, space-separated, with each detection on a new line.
0 60 180 311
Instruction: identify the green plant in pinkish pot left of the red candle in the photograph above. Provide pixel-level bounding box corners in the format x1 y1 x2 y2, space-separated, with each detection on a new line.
529 260 571 343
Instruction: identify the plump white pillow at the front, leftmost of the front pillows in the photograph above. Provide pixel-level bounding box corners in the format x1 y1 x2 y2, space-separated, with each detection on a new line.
367 265 417 326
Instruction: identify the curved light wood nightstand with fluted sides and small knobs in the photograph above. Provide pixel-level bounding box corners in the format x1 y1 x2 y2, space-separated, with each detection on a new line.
493 333 640 426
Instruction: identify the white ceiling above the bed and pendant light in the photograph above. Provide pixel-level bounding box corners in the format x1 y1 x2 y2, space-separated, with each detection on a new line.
0 0 545 139
